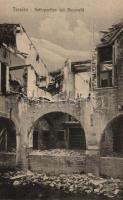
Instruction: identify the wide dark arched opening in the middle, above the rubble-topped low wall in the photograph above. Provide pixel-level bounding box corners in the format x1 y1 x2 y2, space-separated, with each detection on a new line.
33 112 86 150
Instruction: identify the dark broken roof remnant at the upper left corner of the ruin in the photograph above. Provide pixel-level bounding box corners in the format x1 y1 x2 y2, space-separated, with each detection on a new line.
0 23 25 48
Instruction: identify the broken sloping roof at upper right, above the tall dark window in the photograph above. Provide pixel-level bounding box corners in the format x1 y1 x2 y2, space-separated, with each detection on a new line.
97 21 123 47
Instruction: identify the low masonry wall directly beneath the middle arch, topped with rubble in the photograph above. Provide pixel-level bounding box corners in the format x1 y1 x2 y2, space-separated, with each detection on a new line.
29 154 85 175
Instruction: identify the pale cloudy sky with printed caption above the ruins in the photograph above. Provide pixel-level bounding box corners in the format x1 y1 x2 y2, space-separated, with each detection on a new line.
0 0 123 68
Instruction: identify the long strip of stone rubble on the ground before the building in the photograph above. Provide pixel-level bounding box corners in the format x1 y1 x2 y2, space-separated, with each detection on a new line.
1 171 123 199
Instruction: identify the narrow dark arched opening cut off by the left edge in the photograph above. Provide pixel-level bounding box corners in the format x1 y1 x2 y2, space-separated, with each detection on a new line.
0 117 16 152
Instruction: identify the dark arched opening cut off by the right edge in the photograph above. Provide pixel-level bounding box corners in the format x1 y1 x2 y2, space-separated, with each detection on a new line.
100 115 123 156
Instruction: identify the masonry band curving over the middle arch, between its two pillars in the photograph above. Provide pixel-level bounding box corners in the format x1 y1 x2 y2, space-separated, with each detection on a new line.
26 102 85 132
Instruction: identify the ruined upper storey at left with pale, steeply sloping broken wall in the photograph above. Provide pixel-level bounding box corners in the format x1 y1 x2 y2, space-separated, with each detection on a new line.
0 24 49 97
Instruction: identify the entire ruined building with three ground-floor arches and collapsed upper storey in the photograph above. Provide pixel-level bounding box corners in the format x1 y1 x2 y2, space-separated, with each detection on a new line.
0 23 123 177
